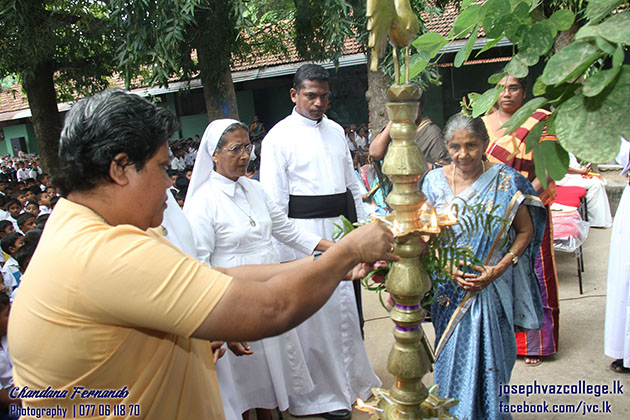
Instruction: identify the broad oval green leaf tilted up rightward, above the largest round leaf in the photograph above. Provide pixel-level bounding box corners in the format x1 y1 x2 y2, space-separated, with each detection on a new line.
541 41 603 85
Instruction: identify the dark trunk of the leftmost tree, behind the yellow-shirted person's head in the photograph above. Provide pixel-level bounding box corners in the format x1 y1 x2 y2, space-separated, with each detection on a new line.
22 63 61 176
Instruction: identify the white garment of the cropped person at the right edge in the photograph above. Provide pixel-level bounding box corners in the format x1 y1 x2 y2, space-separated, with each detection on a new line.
604 185 630 368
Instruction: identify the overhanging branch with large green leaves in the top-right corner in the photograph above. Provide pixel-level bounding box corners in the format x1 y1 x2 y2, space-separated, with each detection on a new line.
410 0 630 174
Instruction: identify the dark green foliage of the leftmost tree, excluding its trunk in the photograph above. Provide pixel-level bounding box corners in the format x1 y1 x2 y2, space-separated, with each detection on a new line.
0 0 116 101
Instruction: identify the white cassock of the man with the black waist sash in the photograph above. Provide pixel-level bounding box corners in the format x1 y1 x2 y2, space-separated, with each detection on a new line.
260 110 381 415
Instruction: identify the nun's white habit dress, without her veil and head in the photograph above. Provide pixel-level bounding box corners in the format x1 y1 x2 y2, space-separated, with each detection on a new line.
185 172 321 420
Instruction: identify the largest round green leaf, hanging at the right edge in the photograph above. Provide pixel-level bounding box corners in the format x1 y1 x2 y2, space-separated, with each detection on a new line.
555 65 630 163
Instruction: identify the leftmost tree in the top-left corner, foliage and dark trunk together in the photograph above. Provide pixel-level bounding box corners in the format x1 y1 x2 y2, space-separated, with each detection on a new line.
0 0 117 170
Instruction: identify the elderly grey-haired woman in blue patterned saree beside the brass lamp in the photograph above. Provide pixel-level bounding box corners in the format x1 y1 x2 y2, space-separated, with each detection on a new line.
422 114 546 420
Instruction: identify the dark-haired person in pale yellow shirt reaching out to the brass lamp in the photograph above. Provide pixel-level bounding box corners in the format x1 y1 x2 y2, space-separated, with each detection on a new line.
9 91 396 419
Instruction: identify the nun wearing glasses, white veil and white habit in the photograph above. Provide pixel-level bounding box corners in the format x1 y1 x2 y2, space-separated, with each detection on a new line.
184 119 332 420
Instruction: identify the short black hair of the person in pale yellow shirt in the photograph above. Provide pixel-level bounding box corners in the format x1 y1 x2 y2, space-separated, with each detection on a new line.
54 90 179 196
